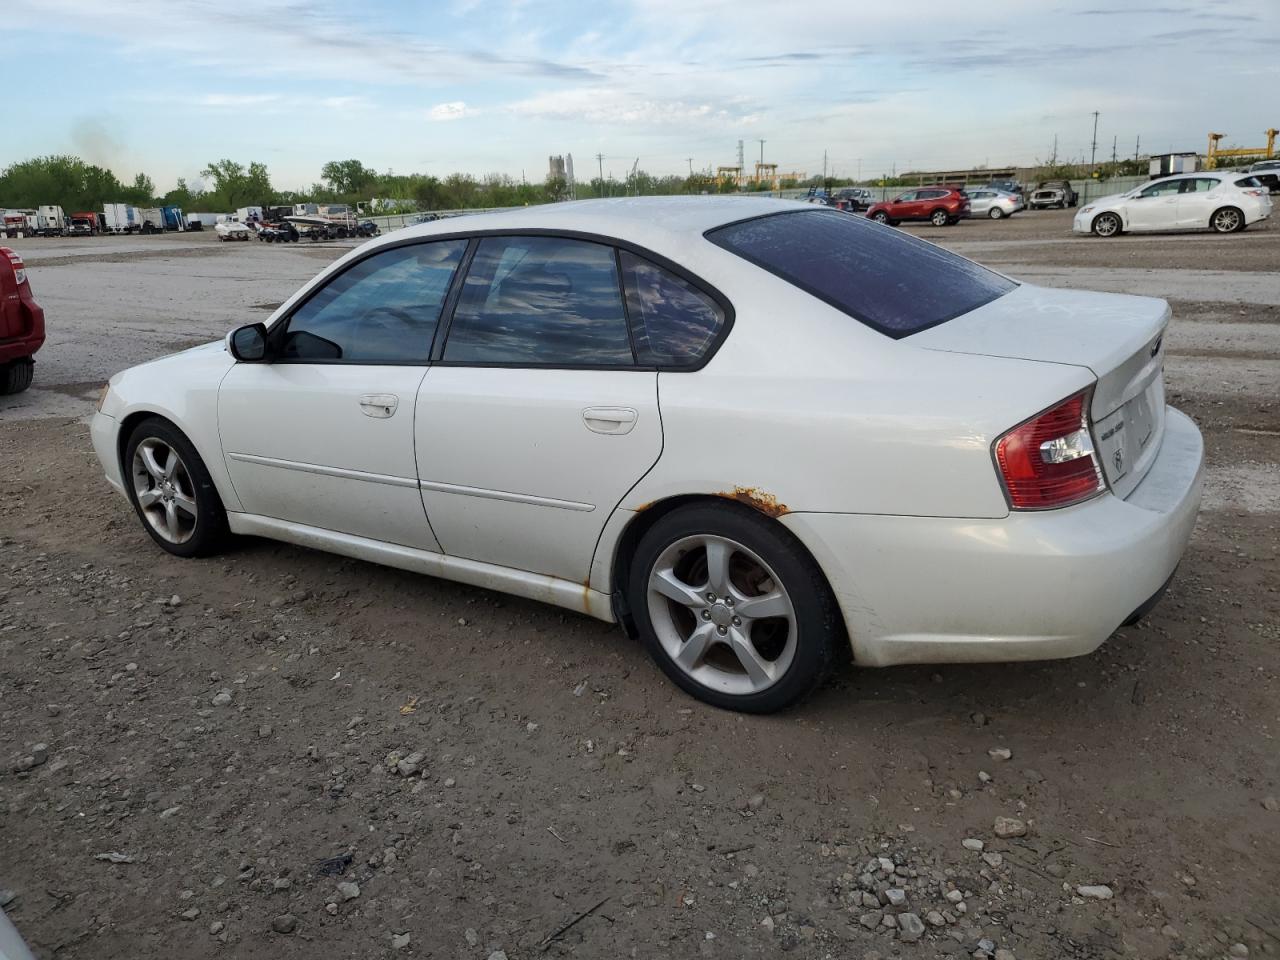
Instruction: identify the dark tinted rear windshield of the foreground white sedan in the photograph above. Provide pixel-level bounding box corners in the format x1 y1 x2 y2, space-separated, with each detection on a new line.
707 210 1018 338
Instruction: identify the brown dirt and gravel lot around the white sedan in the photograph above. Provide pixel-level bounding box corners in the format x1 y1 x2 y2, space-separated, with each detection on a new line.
0 211 1280 960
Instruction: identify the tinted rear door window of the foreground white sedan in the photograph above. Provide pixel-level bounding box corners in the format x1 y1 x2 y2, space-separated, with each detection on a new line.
444 237 634 366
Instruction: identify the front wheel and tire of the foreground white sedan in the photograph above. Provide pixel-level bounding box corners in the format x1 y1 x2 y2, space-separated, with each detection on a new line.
122 417 228 557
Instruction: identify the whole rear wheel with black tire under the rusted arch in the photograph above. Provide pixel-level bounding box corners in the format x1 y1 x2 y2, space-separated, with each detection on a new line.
626 503 842 713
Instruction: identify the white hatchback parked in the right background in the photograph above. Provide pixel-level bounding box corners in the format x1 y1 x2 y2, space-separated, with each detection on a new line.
1071 170 1271 237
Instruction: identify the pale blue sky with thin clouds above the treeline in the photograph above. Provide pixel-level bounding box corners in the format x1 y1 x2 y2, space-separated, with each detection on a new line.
0 0 1280 192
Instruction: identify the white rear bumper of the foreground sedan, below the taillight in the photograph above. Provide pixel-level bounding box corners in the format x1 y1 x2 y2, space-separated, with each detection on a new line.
782 410 1204 666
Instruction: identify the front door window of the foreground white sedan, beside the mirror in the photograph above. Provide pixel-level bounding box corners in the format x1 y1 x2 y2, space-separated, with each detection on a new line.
283 241 467 364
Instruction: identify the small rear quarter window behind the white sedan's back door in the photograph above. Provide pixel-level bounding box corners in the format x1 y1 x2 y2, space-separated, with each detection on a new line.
622 252 724 366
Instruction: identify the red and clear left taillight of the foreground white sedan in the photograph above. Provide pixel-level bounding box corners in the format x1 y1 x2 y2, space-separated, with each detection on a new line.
996 389 1106 509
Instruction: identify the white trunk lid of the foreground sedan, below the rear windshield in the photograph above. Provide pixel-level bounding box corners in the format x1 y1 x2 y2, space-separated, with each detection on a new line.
910 284 1170 498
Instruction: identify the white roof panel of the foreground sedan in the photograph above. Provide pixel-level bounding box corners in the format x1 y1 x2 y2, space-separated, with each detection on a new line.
378 196 814 244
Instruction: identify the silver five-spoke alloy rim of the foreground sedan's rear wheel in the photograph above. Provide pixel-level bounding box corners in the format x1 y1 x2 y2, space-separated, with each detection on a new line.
648 534 796 695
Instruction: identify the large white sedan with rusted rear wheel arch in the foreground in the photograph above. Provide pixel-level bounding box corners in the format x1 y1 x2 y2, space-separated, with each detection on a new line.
92 197 1203 712
